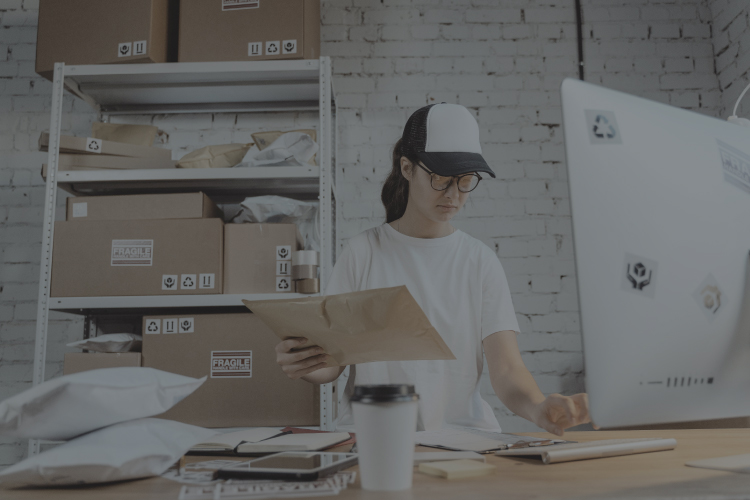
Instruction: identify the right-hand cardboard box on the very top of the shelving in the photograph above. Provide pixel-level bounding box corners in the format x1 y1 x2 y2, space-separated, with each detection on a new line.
178 0 320 62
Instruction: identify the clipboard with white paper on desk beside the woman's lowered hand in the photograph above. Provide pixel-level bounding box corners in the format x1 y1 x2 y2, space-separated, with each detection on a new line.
416 427 568 453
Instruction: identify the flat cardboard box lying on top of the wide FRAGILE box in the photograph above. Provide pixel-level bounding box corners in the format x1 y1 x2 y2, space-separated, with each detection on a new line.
66 193 224 220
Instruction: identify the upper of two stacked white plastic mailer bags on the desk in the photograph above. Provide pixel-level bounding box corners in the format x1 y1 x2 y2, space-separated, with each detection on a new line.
0 367 206 440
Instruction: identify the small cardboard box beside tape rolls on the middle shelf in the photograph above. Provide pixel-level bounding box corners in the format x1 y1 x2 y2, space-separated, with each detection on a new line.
224 224 302 293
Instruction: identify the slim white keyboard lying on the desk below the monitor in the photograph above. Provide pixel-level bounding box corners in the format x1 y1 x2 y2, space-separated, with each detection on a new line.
495 438 677 464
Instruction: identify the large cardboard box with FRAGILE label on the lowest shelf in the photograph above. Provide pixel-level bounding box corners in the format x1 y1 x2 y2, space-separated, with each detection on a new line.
143 313 320 427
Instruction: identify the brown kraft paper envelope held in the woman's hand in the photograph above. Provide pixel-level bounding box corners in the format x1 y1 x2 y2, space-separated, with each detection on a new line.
247 286 456 366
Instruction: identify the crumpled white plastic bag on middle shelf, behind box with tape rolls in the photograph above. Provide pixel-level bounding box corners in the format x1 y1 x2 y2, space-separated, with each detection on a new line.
232 195 320 252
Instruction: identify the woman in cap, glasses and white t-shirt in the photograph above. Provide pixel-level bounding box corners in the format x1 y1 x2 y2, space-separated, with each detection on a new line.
276 103 590 436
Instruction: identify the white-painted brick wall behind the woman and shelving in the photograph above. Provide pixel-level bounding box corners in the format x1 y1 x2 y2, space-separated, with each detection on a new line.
0 0 736 464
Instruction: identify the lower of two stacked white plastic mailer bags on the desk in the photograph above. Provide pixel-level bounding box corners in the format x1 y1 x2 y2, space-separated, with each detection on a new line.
0 418 216 486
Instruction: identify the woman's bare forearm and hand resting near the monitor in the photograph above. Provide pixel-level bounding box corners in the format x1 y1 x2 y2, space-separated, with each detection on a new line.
482 330 591 436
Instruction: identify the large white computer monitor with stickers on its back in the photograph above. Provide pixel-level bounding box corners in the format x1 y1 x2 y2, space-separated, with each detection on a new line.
561 78 750 428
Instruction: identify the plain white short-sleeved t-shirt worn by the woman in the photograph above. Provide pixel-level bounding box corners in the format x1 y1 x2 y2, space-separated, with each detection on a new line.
325 224 519 430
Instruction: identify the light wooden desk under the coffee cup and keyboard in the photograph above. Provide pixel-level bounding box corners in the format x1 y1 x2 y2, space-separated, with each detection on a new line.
0 429 750 500
